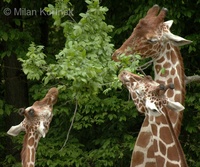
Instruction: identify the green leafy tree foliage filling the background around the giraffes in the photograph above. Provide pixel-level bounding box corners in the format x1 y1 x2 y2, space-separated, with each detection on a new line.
0 0 200 167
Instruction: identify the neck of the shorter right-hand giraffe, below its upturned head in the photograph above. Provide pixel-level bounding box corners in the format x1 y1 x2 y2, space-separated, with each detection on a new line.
150 107 187 167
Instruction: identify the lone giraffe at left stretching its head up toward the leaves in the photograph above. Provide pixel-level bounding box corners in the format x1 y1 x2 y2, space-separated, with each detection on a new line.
7 87 58 167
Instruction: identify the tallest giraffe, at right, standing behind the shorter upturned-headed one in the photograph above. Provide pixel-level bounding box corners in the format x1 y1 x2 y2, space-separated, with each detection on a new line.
112 5 192 166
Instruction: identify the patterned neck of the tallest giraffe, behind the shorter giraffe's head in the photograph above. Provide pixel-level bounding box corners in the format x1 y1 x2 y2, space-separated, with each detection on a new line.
154 43 185 136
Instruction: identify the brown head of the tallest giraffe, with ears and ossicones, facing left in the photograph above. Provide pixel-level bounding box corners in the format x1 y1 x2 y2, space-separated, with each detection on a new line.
112 5 192 61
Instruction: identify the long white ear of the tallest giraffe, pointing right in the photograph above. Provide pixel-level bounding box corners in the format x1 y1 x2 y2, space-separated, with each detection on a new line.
165 31 192 46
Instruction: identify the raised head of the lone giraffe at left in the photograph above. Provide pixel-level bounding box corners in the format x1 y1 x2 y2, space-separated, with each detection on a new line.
7 88 58 137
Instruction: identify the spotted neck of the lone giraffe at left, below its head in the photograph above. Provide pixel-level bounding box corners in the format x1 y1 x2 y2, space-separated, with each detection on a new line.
21 129 40 167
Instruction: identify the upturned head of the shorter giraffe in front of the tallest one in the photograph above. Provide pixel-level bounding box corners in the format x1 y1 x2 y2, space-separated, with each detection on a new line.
119 71 184 116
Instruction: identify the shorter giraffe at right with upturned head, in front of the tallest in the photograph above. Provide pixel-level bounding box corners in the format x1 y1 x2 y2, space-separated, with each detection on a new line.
119 71 187 167
